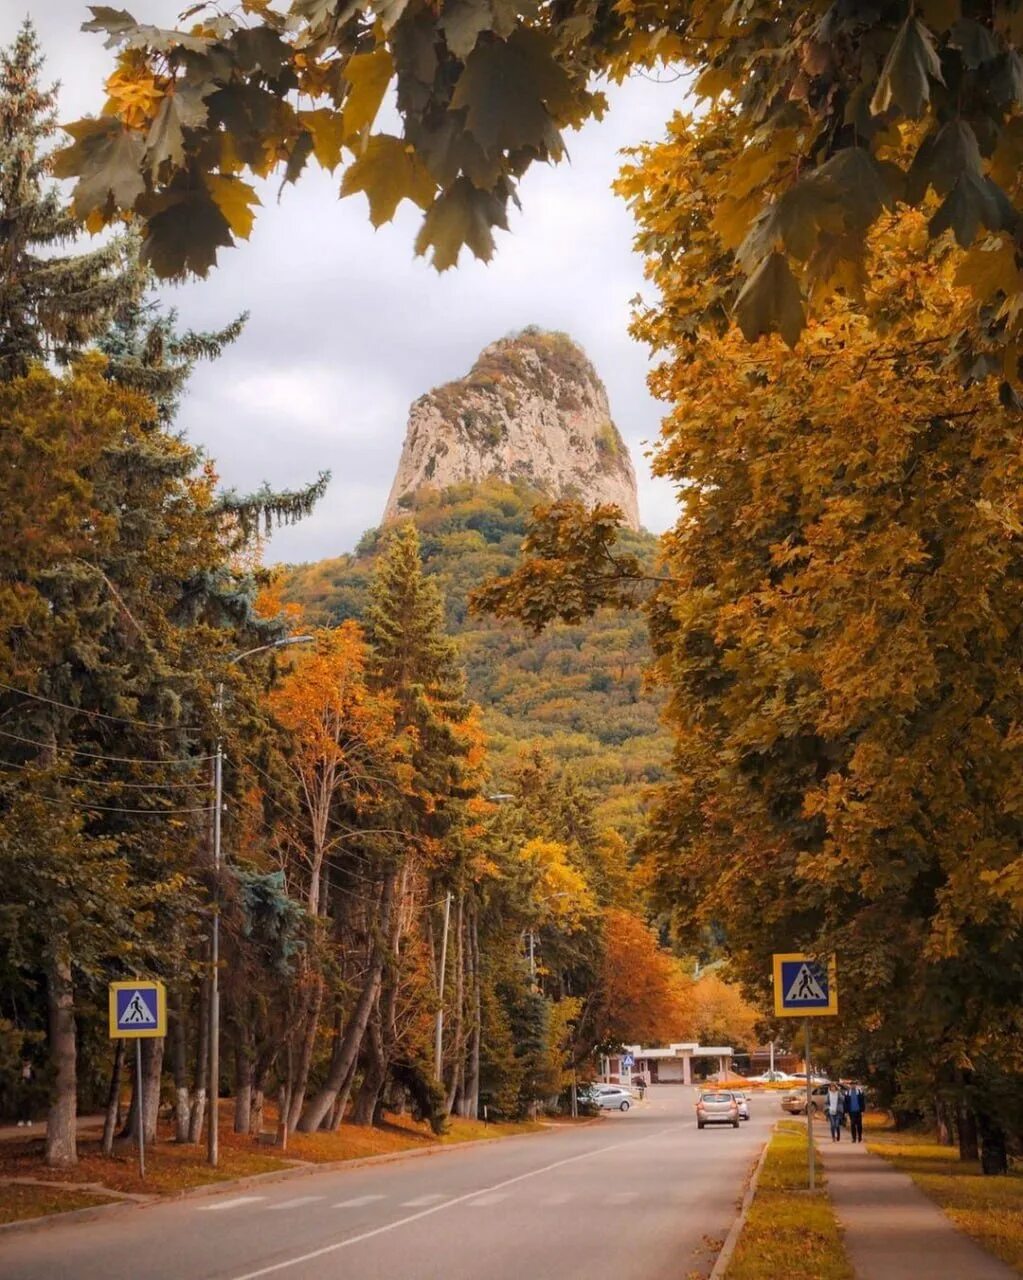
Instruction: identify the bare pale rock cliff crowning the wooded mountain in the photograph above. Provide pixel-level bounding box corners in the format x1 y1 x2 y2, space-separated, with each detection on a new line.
384 329 639 529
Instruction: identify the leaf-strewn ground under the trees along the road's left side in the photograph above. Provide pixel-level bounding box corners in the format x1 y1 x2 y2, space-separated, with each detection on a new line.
0 1102 543 1222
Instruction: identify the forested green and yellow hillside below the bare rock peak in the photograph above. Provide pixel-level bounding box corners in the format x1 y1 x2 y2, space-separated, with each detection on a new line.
282 480 670 837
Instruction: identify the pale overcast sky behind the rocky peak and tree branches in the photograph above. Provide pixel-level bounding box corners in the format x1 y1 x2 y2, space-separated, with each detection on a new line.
10 0 682 561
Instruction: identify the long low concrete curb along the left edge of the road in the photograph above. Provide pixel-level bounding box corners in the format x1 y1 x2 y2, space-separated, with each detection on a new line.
0 1116 591 1236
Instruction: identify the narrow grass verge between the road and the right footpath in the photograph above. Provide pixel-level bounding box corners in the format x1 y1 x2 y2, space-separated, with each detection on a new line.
726 1120 853 1280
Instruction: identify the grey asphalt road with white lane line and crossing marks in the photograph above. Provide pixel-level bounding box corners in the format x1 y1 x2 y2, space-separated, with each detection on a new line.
0 1085 778 1280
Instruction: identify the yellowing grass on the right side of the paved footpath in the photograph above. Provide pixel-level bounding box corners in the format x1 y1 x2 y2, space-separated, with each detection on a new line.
867 1128 1023 1272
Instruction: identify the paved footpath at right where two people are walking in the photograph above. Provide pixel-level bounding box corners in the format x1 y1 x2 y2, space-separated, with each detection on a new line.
817 1134 1019 1280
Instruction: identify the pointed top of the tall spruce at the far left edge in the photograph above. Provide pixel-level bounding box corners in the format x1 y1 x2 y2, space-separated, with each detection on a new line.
0 20 142 379
